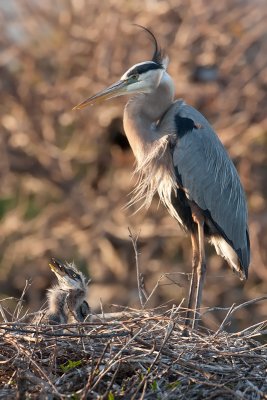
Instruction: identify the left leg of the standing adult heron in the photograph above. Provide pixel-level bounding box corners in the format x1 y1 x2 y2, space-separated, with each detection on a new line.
185 232 199 326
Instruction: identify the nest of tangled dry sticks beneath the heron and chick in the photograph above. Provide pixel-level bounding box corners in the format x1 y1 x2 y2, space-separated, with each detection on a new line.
0 306 267 400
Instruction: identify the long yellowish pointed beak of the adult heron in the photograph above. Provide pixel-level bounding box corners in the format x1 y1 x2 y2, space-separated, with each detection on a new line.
73 80 128 110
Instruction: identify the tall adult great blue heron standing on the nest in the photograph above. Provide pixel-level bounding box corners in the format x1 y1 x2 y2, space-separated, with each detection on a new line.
74 27 250 327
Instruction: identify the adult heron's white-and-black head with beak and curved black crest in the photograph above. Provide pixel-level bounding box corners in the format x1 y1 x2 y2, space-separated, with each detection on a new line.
74 27 168 110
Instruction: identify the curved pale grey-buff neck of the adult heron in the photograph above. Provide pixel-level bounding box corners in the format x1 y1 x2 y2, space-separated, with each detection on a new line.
123 72 174 163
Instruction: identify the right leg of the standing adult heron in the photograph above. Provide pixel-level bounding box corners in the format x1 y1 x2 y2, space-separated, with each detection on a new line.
193 213 206 329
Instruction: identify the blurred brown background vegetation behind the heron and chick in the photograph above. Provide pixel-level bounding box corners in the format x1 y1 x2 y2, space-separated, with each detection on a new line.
0 0 267 328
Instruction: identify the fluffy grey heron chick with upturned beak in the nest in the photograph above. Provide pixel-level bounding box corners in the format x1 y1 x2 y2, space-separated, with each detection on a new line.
45 258 90 324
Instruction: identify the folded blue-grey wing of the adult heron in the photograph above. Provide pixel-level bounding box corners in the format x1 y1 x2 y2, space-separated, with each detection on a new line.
169 101 250 269
